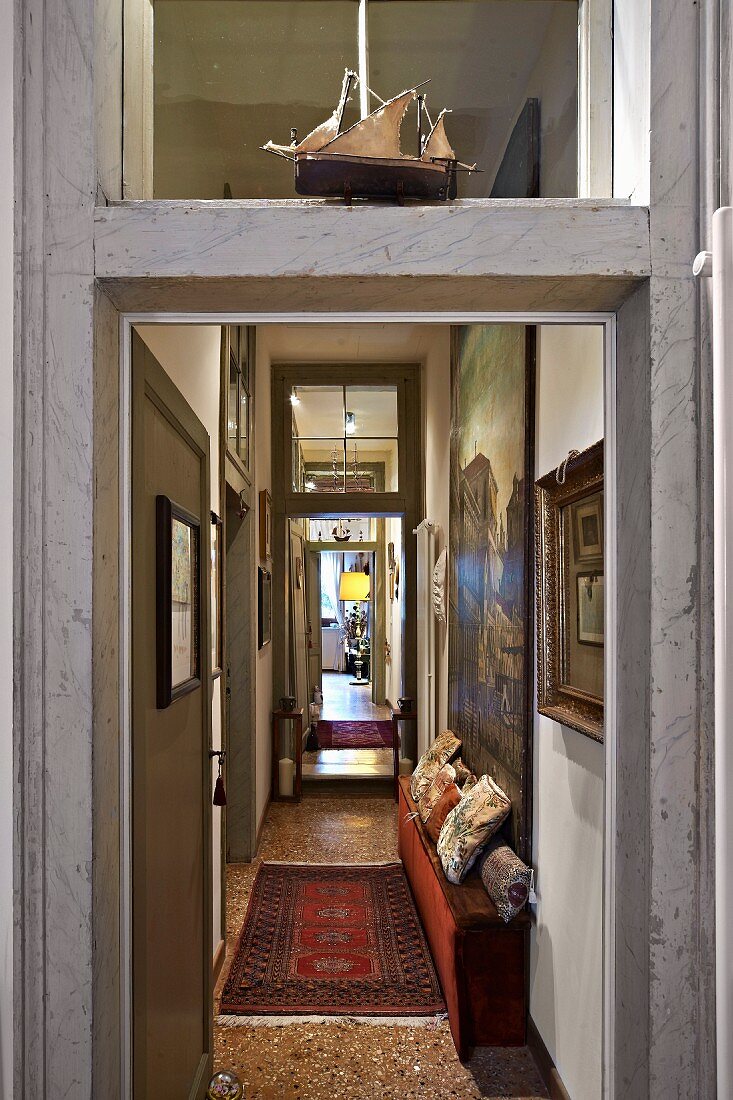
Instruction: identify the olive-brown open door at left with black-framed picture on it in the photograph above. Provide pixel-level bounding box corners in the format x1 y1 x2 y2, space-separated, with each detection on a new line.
132 333 212 1100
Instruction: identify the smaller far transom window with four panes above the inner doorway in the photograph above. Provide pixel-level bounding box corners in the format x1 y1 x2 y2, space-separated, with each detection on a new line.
288 385 398 493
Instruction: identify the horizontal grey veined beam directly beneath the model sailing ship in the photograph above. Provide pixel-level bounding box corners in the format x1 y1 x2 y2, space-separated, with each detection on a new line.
95 199 650 279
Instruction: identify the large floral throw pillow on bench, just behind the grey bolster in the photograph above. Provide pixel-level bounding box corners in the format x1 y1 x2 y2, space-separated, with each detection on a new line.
438 776 512 883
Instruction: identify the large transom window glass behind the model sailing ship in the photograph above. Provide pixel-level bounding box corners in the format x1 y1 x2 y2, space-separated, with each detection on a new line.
132 0 594 199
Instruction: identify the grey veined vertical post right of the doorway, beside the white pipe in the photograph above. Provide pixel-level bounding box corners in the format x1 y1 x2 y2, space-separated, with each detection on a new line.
648 0 715 1098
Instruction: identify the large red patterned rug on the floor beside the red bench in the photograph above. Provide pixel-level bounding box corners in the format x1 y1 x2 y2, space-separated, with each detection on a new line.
219 864 445 1023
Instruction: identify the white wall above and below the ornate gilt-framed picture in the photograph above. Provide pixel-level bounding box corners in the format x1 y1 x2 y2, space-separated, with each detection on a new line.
529 326 604 1100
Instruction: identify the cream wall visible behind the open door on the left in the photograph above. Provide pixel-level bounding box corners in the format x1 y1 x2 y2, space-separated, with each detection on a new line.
136 325 222 952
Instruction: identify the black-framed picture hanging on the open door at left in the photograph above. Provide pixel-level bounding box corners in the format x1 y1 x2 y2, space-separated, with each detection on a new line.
155 496 203 710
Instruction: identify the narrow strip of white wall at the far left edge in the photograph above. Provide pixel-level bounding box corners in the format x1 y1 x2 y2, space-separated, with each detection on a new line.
0 3 15 1082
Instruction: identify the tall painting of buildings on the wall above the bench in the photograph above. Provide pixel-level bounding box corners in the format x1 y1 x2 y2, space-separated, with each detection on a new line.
448 325 534 857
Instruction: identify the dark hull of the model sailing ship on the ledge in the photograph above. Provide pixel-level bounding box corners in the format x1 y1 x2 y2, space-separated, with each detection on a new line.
295 153 457 202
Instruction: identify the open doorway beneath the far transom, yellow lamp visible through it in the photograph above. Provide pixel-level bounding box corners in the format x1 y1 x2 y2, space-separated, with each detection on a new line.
291 516 404 782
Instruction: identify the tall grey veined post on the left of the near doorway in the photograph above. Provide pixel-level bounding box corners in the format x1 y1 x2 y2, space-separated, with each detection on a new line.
14 0 96 1100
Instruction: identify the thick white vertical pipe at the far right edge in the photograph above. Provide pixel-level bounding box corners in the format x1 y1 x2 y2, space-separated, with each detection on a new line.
693 207 733 1097
